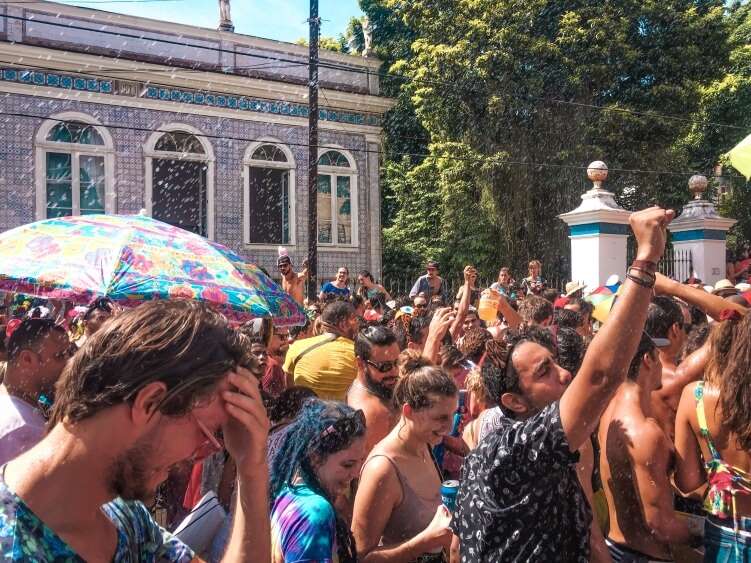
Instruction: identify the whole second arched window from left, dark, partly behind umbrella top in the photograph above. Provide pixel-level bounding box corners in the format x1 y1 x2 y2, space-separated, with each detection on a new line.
144 124 213 238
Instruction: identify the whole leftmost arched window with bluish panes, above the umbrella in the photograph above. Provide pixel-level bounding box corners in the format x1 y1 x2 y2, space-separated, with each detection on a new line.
35 113 115 219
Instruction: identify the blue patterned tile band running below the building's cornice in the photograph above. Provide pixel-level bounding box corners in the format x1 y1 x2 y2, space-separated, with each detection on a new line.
0 68 381 127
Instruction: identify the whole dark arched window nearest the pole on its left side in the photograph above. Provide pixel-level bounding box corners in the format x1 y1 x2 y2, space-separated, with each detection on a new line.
243 140 295 245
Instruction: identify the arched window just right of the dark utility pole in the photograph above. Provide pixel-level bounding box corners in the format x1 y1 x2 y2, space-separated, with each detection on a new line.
318 150 357 246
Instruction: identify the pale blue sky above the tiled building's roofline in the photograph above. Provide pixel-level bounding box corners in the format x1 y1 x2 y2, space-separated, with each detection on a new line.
58 0 363 41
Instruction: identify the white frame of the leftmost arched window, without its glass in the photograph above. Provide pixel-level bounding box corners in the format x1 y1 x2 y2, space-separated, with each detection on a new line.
34 111 117 221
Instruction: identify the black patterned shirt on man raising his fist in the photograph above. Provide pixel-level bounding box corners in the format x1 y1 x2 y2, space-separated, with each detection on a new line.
451 402 592 563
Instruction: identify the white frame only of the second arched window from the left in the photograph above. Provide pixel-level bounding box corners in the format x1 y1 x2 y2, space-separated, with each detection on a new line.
143 123 216 240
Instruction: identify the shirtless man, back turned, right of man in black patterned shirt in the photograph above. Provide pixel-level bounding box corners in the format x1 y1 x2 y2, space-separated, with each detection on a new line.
598 334 701 562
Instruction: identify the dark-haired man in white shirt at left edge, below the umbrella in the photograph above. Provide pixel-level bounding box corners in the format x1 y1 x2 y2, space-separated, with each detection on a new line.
0 318 71 465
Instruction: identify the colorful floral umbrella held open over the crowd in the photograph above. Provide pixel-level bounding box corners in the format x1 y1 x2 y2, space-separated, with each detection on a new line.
0 215 305 325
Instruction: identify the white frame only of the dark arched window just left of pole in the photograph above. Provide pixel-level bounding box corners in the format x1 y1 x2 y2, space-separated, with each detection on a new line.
242 137 297 249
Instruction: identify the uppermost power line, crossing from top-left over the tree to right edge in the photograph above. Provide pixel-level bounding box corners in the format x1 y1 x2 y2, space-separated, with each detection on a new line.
2 14 747 131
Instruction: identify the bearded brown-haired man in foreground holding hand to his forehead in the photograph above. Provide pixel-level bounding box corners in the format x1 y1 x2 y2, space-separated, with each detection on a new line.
0 300 271 563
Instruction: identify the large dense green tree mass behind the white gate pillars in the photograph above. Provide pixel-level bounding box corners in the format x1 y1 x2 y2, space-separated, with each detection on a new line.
361 0 729 275
